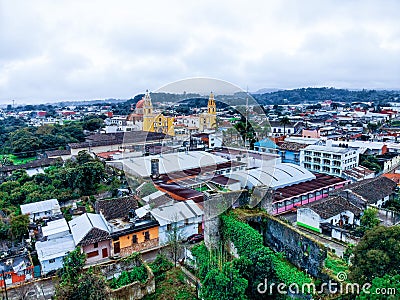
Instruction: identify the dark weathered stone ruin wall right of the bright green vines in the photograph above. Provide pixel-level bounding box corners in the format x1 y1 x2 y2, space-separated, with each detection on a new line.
247 215 327 278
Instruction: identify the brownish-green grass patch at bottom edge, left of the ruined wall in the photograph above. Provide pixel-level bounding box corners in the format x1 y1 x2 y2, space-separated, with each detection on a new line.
143 268 197 300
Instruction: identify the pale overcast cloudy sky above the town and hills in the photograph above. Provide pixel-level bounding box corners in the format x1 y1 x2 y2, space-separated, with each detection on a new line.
0 0 400 104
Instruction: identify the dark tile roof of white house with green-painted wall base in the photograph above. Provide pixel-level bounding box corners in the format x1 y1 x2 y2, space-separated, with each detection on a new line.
304 196 361 219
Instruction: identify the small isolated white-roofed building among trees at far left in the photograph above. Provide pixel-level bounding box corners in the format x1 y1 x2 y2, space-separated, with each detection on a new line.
21 199 61 222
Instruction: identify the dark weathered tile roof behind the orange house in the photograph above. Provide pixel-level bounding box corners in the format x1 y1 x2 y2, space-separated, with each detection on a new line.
95 196 139 221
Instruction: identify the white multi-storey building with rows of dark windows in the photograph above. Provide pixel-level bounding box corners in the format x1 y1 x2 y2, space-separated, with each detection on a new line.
300 140 359 177
